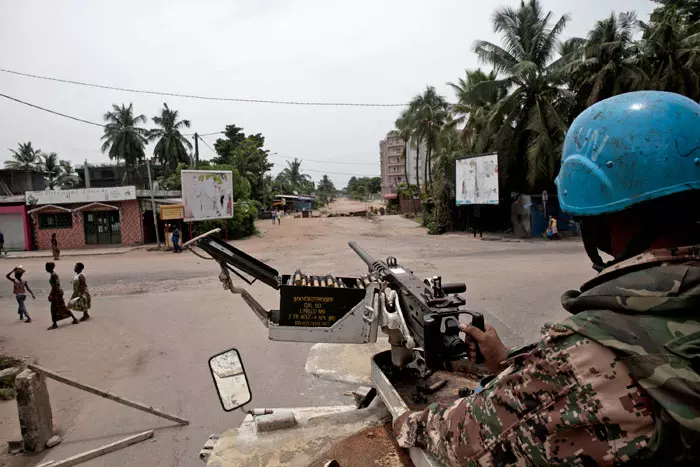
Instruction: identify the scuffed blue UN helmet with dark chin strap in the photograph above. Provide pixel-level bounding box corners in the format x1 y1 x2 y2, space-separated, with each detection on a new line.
556 91 700 263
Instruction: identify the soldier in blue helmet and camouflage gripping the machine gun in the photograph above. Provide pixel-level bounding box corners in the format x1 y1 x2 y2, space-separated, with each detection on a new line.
394 91 700 466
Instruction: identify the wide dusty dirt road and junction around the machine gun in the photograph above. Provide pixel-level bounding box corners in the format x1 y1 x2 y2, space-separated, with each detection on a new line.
0 210 592 466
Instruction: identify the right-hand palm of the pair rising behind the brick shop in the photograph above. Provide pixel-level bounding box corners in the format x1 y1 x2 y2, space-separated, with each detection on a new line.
148 102 191 175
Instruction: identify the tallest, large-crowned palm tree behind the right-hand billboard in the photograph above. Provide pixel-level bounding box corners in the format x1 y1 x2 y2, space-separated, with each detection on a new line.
474 0 573 190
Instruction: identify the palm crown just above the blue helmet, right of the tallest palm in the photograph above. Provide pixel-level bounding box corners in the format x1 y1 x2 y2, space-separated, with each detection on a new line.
562 12 646 107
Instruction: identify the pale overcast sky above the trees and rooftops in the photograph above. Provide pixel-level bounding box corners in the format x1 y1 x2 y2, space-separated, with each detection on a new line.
0 0 655 188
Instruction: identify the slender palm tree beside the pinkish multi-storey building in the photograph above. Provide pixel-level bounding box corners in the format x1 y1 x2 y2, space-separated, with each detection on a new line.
408 86 449 190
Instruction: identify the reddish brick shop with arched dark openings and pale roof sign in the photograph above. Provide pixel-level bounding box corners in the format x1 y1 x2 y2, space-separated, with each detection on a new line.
25 186 143 250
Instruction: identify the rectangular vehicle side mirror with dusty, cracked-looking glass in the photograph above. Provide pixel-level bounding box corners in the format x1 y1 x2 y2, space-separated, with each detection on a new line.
209 349 253 412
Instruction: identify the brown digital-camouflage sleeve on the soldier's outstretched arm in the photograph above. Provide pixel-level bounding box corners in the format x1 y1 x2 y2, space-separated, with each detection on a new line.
394 325 653 466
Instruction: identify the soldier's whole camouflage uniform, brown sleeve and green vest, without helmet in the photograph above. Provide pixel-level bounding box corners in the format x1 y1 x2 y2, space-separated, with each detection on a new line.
394 246 700 466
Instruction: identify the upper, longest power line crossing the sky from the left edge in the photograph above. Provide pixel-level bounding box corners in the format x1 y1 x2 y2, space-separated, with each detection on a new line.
0 68 407 107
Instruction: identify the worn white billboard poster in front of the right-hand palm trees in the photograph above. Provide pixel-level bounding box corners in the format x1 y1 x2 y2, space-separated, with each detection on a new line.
455 153 498 206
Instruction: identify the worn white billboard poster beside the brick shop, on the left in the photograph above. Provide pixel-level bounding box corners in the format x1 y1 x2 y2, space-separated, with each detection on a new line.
181 170 233 222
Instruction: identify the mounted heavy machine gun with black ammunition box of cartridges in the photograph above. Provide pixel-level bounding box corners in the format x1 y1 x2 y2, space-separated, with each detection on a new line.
183 229 484 376
